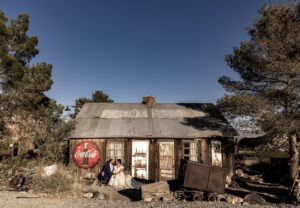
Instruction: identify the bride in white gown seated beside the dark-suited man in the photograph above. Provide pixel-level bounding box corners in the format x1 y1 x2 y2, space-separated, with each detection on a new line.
108 159 141 189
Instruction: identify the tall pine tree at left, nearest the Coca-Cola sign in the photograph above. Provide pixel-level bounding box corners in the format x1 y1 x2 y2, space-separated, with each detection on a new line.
0 10 67 161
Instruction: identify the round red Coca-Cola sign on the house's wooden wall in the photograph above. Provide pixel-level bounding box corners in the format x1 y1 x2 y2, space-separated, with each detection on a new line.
73 141 100 168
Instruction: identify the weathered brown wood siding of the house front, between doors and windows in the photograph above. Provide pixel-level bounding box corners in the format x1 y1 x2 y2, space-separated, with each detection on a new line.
69 138 234 181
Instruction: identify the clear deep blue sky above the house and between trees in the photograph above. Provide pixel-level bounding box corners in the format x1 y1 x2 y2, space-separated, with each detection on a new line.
0 0 265 105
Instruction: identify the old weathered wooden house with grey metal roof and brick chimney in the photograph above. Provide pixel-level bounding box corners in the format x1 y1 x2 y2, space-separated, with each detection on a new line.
69 96 236 181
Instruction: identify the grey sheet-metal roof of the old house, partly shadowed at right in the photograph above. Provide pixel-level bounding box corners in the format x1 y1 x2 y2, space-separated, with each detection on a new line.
70 103 236 138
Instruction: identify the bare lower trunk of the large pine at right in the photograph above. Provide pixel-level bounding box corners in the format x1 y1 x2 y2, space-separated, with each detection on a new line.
289 134 299 182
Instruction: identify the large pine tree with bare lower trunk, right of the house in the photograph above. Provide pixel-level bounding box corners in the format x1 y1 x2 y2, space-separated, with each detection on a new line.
218 2 300 184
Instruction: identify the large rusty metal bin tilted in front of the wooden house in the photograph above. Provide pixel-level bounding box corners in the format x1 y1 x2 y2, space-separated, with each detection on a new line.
179 160 226 193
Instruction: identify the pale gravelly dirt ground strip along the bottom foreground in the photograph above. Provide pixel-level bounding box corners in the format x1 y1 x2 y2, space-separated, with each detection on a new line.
0 191 295 208
